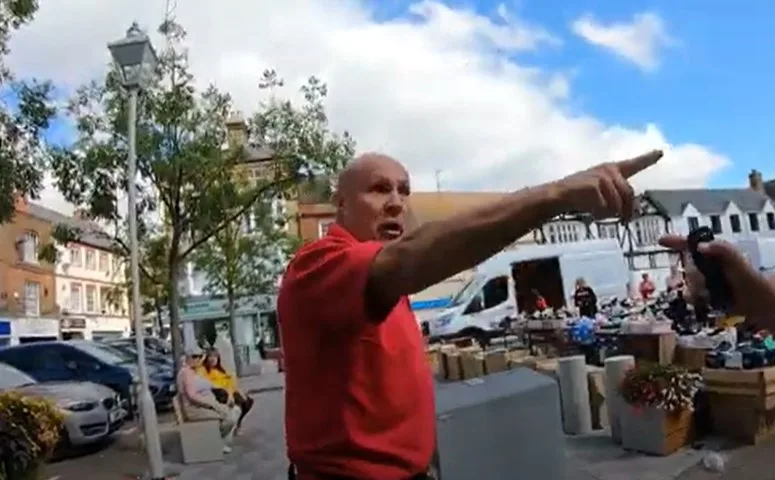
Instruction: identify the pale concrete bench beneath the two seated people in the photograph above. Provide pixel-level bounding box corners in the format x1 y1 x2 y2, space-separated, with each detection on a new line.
172 395 224 464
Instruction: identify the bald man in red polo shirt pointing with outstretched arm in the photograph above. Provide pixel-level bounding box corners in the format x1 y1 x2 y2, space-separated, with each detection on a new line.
277 151 662 480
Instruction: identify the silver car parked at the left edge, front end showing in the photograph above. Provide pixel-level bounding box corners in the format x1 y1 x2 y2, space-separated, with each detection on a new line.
0 363 127 446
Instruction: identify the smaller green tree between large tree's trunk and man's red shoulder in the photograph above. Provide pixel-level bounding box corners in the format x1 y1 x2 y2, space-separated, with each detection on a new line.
193 187 293 372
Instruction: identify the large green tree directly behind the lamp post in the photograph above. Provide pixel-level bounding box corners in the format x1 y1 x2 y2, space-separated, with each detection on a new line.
45 22 352 361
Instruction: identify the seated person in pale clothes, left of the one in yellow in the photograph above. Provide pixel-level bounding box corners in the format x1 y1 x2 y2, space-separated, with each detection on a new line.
177 348 240 453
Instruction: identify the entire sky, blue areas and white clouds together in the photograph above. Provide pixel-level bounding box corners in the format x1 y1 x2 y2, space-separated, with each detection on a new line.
21 0 775 197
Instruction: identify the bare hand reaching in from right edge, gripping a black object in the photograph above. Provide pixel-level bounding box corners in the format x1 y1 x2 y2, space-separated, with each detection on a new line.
659 235 775 331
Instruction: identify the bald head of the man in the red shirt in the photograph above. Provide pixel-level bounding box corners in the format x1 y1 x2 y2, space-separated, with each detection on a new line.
334 153 410 241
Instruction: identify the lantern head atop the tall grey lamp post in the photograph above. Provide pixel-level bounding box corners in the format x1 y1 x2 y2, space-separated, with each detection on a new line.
108 22 158 89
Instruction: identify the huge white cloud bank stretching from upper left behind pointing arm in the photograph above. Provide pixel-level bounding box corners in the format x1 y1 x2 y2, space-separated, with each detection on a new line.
10 0 728 214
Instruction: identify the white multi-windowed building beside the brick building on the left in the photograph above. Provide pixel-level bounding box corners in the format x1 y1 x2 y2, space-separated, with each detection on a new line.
55 211 131 340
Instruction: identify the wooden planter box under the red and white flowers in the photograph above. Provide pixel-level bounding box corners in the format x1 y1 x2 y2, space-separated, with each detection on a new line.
621 406 693 455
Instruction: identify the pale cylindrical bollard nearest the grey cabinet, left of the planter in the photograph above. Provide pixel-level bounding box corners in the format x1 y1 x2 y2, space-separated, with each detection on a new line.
557 355 592 435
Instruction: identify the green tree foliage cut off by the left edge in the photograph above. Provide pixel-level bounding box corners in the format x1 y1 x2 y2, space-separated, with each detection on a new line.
0 0 56 224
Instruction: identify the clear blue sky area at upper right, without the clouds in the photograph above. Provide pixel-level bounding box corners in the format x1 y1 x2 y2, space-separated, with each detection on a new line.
364 0 775 187
